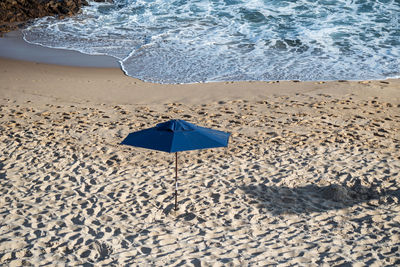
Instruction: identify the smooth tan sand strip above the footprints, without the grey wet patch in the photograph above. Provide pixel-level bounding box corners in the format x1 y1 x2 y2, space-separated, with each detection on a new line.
0 57 400 104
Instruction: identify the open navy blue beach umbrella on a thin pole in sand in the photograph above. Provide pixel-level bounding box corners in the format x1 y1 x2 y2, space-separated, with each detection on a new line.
121 120 230 210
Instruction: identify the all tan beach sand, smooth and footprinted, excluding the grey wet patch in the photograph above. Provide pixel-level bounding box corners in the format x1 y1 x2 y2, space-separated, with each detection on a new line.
0 59 400 266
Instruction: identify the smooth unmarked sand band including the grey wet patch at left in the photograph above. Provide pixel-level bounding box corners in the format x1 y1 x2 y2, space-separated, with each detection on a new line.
0 31 400 104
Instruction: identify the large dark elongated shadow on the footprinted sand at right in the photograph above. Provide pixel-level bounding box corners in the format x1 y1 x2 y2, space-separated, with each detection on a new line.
241 182 400 215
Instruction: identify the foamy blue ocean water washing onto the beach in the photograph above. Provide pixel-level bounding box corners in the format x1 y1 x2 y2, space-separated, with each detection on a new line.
23 0 400 83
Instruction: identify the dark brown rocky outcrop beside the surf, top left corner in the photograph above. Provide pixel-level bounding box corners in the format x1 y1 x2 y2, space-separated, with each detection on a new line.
0 0 88 32
